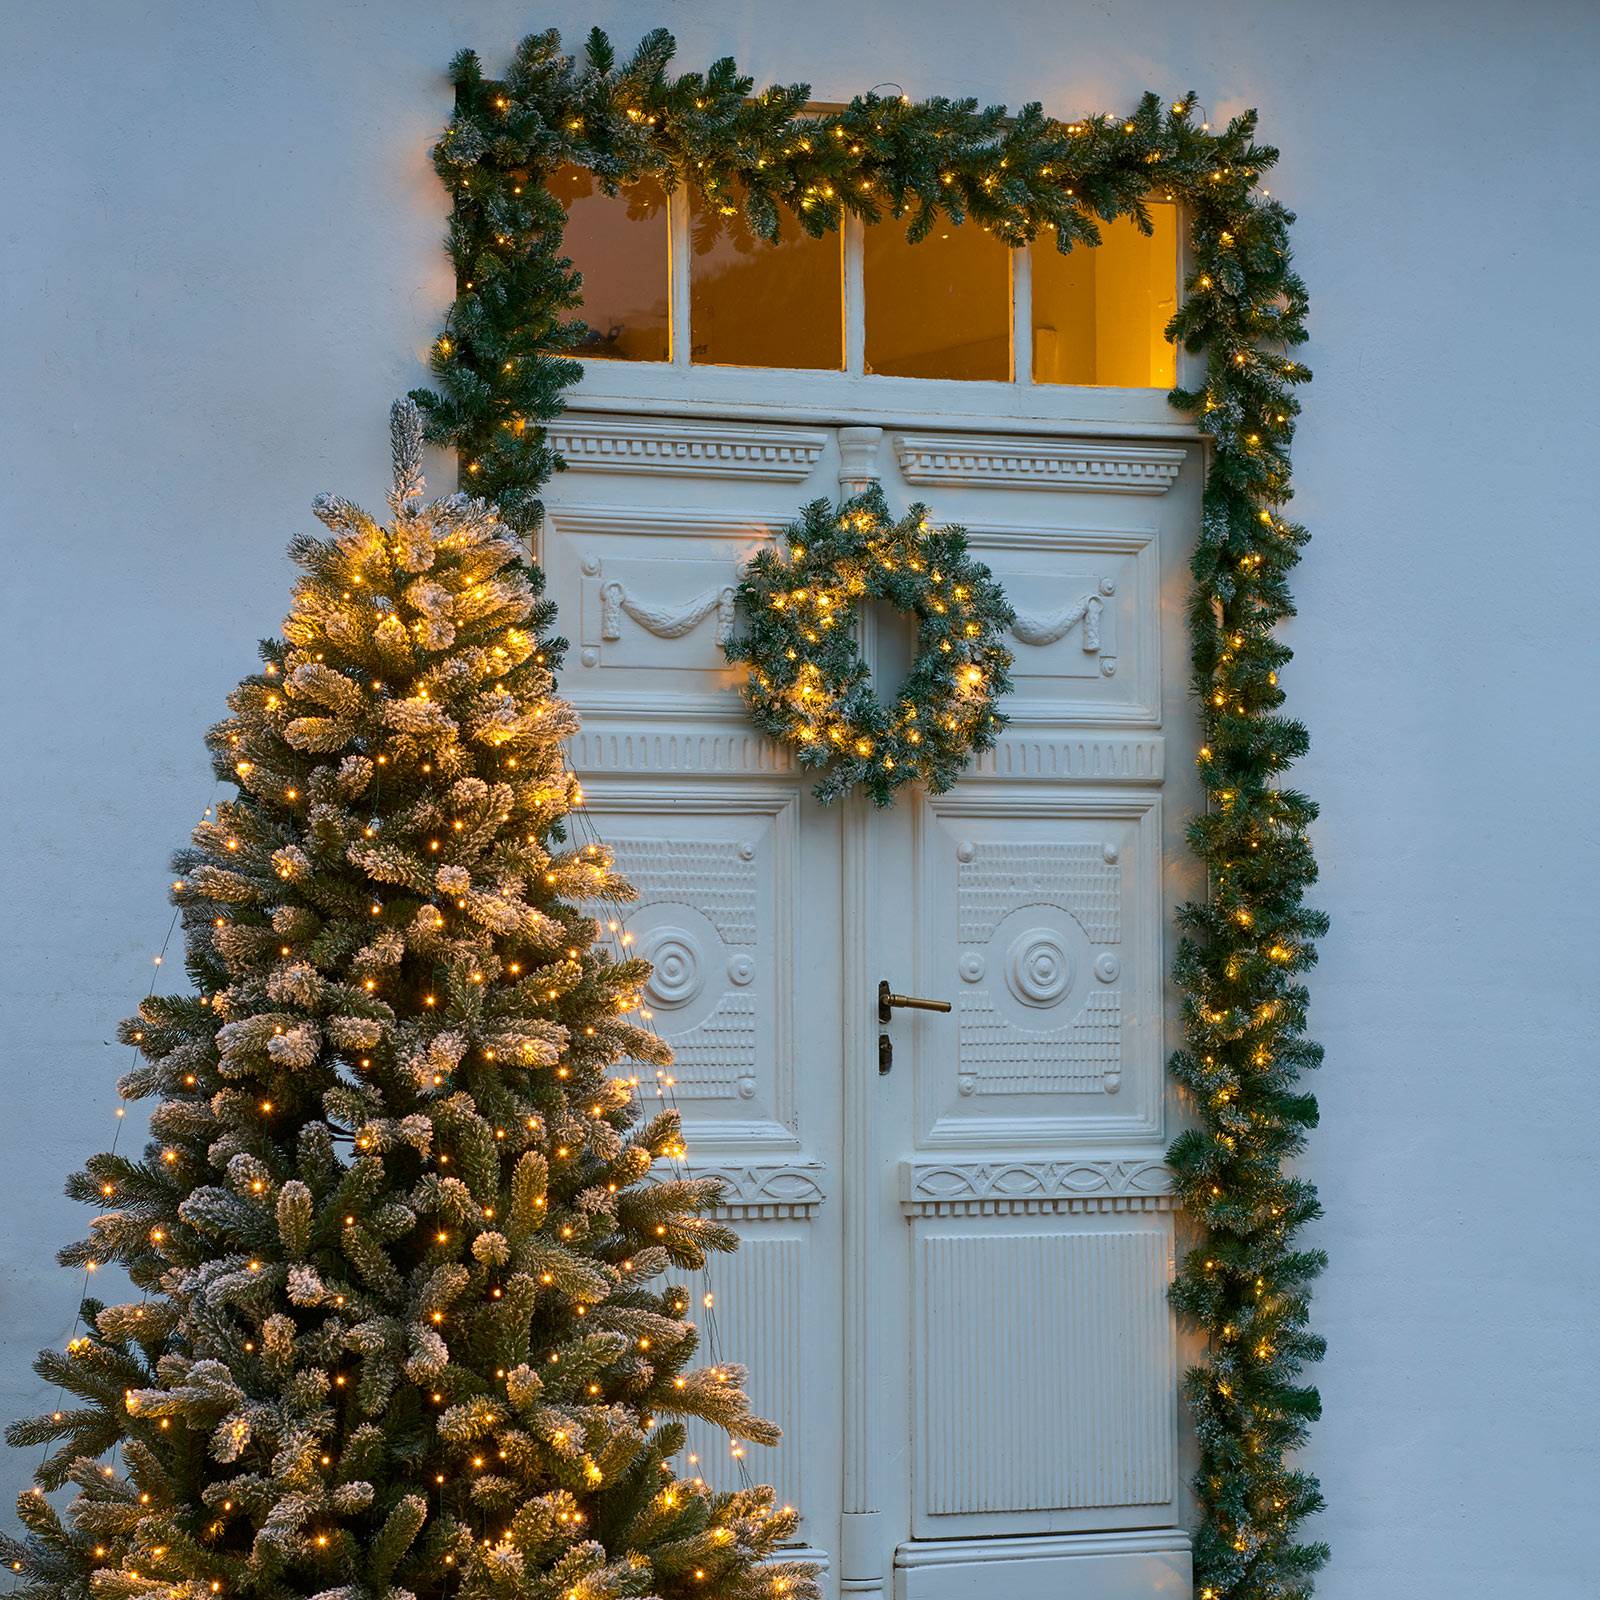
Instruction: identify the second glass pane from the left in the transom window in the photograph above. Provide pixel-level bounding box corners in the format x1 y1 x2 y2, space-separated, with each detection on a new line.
690 190 845 371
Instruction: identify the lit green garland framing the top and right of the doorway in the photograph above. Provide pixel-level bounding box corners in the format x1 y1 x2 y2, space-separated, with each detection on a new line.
416 32 1326 1600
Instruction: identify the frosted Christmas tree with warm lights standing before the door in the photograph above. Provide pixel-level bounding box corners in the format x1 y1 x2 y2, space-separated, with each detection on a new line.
3 402 816 1600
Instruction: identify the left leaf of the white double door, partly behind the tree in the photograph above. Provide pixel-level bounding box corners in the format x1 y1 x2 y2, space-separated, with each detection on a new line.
538 432 842 1558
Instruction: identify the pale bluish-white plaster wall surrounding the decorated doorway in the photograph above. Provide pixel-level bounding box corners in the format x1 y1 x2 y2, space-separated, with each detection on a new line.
0 0 1600 1600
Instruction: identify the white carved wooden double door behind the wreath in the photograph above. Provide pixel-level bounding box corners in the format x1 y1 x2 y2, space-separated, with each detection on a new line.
541 413 1200 1600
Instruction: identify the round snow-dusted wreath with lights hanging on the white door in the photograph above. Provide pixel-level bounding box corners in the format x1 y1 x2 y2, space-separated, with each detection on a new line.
723 483 1013 806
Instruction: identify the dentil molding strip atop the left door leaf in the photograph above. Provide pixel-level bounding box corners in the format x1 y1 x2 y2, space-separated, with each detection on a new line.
549 416 827 483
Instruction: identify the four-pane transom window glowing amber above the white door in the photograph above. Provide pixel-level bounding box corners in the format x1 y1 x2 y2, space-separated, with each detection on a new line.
552 168 1179 389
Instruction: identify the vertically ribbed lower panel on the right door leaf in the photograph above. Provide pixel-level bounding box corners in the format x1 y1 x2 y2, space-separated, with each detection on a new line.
918 1229 1173 1515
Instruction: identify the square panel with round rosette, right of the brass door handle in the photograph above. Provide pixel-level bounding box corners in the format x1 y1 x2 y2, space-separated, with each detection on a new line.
917 793 1162 1150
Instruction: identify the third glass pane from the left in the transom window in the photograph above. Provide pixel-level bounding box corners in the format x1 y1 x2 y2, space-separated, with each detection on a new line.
866 221 1011 382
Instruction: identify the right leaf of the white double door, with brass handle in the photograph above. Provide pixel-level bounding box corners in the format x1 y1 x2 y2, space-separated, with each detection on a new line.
846 435 1198 1600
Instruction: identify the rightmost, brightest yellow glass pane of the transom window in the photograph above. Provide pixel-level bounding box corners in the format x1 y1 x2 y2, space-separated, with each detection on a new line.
1030 202 1178 389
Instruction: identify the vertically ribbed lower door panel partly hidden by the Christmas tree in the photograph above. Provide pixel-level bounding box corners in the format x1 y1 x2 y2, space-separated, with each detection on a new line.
680 1229 806 1512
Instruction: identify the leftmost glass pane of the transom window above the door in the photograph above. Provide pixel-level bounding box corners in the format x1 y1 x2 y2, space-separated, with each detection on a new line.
550 166 670 362
